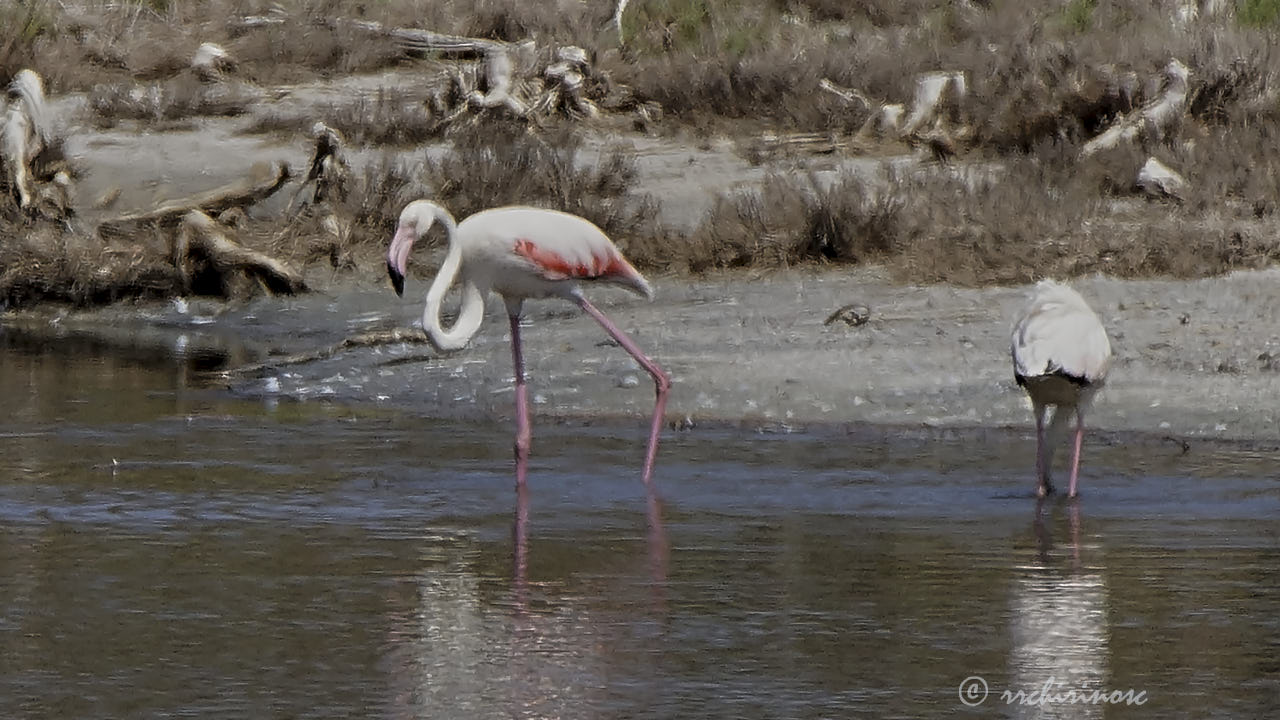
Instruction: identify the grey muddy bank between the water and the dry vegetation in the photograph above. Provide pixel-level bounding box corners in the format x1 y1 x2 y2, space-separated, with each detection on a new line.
6 260 1280 447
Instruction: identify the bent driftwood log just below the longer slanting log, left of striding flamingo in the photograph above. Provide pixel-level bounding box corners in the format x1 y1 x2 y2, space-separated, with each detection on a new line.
170 210 307 295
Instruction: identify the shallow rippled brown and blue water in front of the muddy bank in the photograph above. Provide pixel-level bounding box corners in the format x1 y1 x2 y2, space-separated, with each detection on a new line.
0 333 1280 717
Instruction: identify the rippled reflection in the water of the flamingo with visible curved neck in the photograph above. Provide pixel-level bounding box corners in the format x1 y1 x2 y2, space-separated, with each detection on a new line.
381 495 667 719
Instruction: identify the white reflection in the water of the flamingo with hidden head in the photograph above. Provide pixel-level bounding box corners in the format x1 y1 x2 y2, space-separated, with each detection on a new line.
998 502 1108 719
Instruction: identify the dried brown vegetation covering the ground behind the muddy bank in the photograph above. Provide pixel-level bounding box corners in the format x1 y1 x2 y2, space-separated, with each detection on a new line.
0 0 1280 302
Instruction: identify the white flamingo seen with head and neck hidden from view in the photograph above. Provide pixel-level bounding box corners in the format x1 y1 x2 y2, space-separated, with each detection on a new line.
1011 281 1111 497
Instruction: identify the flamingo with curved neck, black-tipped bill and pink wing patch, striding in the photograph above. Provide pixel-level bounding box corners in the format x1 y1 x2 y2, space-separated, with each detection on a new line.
387 200 671 486
